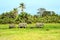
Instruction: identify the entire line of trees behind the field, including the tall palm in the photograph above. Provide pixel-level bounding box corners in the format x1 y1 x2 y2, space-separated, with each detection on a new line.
0 3 60 24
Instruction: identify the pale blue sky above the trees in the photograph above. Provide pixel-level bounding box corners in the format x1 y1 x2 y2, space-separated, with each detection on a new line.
0 0 60 14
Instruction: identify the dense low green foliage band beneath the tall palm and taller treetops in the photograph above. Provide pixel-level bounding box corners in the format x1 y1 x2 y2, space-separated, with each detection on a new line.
0 12 60 24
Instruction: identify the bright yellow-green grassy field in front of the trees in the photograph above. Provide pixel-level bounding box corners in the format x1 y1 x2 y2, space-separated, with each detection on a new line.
0 23 60 40
